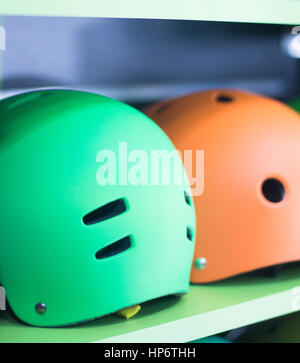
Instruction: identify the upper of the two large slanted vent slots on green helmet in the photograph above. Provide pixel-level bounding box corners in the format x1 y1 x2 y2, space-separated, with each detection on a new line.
83 199 127 226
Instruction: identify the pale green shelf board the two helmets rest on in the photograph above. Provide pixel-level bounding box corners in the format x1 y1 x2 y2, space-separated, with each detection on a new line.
0 266 300 343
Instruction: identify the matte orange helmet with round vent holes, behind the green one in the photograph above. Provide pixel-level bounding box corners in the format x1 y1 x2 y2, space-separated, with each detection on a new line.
145 90 300 283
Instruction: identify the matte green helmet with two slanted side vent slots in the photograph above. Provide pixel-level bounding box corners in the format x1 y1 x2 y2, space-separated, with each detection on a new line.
0 90 195 327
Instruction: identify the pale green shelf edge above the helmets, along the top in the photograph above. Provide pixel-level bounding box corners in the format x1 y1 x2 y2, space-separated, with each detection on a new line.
0 0 300 24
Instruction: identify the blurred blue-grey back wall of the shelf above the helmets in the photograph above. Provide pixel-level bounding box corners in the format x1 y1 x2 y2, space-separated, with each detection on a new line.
0 17 300 105
